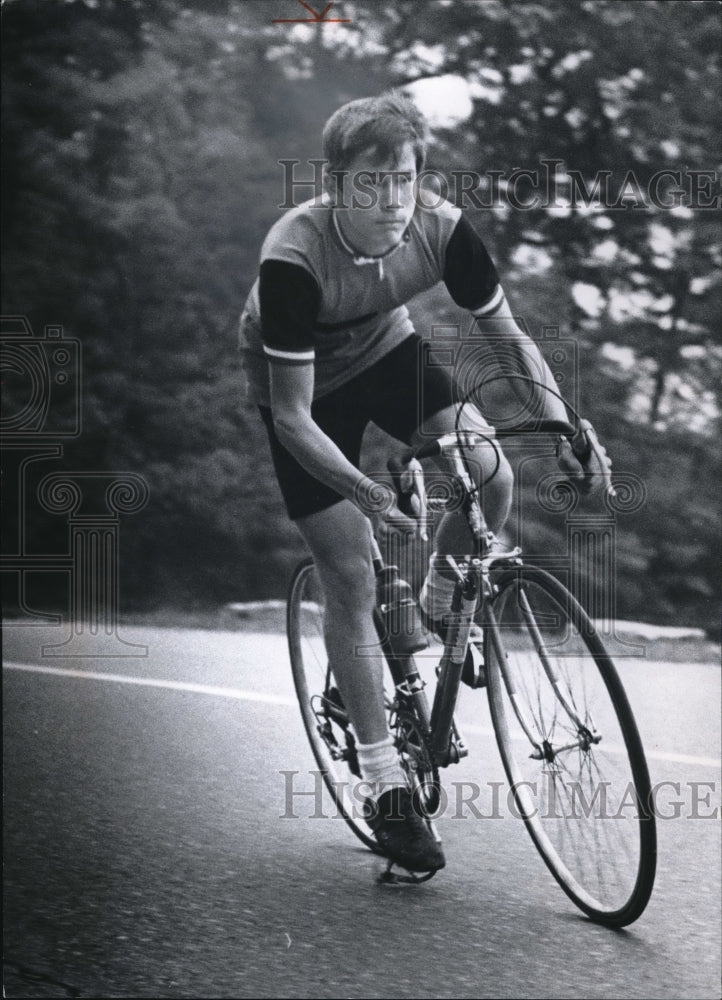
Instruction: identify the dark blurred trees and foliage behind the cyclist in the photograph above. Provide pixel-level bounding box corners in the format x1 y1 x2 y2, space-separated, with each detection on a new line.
2 0 722 631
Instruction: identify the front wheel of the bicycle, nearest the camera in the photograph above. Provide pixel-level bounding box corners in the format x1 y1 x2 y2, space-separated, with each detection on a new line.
485 567 656 927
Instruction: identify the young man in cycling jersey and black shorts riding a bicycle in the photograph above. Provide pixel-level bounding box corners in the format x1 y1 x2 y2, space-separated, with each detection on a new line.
241 91 596 871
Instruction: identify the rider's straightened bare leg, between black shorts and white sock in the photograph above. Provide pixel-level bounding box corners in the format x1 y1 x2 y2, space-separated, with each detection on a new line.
297 500 389 743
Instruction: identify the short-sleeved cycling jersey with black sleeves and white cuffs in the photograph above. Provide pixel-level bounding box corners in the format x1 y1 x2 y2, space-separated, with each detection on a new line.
240 201 499 406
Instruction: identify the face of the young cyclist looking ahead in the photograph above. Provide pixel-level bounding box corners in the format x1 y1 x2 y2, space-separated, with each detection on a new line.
328 143 416 256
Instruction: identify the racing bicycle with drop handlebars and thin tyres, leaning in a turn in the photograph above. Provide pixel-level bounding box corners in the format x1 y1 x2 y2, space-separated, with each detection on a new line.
287 410 656 927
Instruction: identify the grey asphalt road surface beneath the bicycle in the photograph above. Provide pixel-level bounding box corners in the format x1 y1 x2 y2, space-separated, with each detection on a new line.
4 628 720 998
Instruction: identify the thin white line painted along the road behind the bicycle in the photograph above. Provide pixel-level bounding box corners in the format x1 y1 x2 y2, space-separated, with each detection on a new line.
3 662 720 768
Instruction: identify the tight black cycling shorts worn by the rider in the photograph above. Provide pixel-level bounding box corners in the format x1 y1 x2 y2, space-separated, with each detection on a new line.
258 334 454 521
